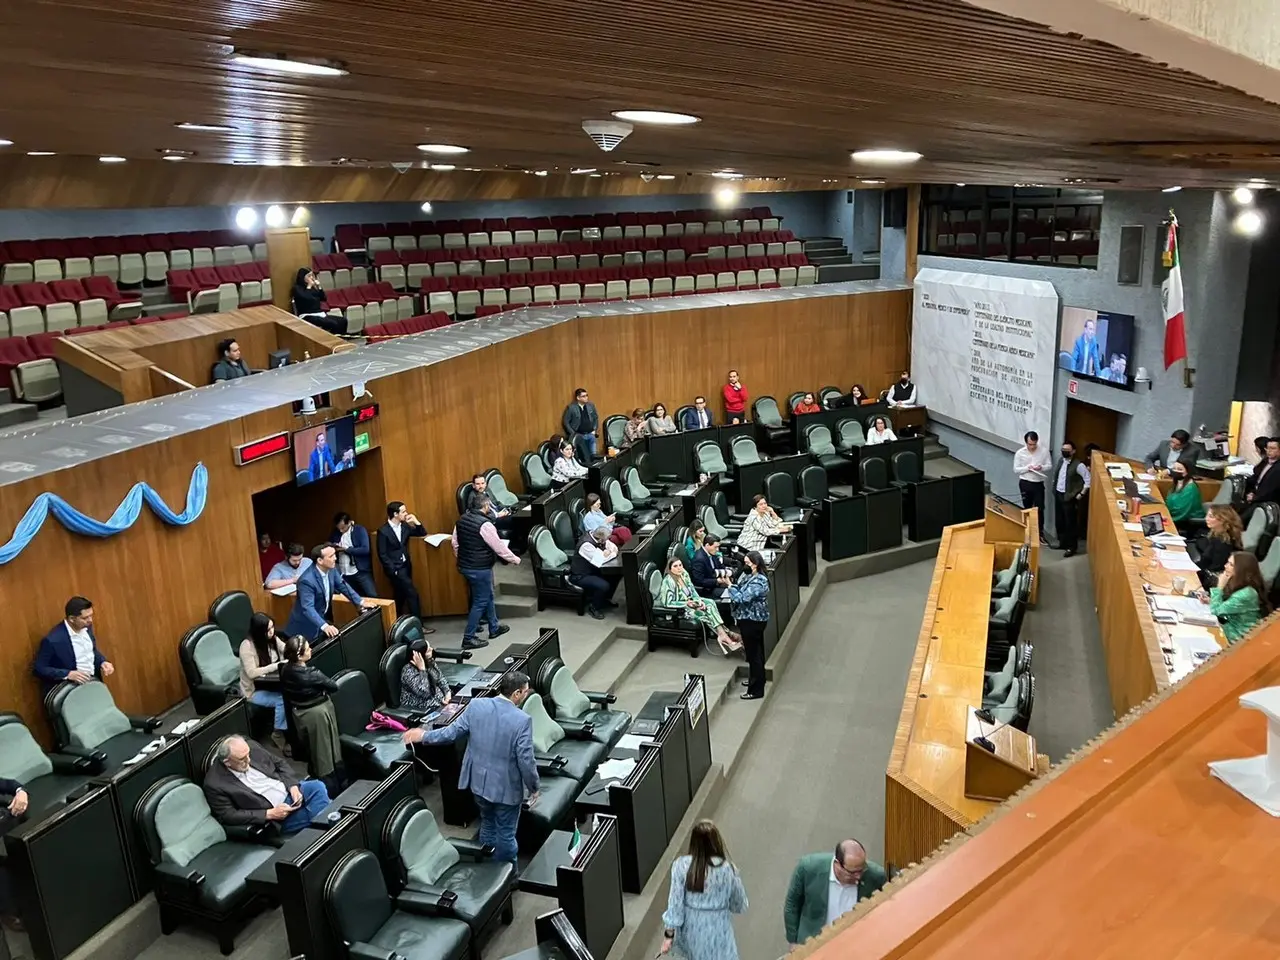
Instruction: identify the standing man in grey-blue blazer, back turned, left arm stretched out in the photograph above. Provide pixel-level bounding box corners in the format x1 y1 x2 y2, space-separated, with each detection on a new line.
403 669 541 863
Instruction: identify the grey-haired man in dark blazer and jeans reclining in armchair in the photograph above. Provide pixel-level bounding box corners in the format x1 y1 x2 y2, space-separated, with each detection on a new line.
205 736 329 837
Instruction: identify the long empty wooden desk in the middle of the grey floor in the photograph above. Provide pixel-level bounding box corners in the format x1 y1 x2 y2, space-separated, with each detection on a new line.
884 521 996 867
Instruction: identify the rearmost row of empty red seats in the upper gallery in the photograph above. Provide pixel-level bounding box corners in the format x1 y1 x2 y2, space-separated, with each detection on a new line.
334 206 781 253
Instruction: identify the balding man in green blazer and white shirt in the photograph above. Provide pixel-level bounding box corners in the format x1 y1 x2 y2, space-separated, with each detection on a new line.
782 840 888 945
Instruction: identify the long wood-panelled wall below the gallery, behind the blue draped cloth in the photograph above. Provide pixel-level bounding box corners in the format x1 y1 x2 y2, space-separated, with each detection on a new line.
0 291 910 742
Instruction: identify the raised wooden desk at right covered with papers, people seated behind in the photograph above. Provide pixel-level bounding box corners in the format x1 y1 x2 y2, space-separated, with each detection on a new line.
1089 452 1226 717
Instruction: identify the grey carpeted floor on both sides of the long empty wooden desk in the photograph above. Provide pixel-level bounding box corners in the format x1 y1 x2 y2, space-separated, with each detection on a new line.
686 550 1111 960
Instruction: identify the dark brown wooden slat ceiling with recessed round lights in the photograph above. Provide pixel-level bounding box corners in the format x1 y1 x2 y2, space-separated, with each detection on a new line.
0 0 1280 187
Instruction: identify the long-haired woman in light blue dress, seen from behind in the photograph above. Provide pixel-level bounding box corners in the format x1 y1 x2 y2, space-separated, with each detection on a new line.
662 820 746 960
